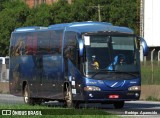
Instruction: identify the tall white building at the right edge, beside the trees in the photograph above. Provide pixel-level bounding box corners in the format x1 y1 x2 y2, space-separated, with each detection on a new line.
140 0 160 61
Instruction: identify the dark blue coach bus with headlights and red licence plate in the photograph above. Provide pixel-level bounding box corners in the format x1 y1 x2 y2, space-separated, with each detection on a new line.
9 21 148 108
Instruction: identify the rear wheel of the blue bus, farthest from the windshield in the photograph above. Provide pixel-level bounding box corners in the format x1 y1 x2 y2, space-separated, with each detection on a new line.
23 85 34 105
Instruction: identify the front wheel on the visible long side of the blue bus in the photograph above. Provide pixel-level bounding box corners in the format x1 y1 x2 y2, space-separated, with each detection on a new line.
64 85 79 108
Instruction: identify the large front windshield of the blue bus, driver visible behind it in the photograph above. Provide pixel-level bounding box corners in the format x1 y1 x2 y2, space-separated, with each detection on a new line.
83 35 139 76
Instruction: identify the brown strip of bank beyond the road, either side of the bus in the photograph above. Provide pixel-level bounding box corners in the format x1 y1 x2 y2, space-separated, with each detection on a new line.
0 82 160 100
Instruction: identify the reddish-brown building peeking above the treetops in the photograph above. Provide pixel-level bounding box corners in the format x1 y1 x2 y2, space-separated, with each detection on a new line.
24 0 72 8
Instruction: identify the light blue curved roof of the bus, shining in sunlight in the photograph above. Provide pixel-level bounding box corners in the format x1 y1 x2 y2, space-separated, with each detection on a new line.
14 21 133 34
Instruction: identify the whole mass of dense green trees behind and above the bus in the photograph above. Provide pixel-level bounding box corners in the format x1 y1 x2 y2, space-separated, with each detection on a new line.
0 0 140 56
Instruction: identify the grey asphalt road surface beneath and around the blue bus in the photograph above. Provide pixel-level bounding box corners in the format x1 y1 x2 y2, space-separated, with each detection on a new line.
0 94 160 118
